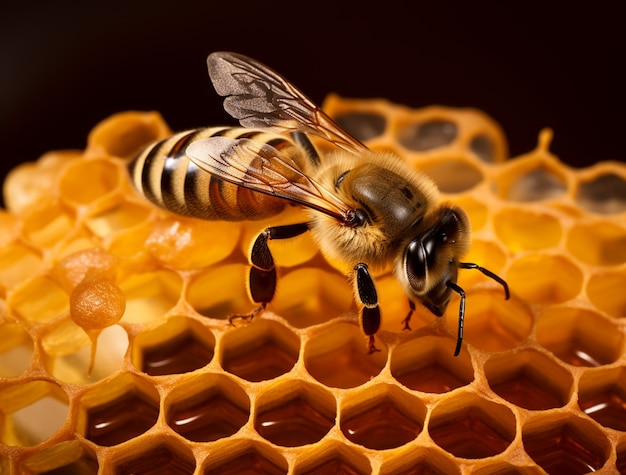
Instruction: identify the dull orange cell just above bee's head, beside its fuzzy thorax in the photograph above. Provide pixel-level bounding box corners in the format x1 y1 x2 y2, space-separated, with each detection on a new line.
419 158 483 193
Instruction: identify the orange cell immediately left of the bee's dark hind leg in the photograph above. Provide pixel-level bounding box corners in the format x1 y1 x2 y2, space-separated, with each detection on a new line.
184 263 249 320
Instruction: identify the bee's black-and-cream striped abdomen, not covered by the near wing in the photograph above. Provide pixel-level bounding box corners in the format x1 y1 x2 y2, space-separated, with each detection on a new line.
128 127 292 221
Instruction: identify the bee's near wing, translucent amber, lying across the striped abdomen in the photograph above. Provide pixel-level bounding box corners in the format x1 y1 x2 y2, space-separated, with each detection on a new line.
186 137 353 222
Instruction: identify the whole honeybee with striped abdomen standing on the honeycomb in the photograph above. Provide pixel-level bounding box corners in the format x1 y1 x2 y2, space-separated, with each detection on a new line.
129 52 509 356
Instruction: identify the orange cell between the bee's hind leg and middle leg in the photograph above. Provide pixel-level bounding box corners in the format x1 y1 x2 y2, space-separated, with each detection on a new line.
271 268 354 328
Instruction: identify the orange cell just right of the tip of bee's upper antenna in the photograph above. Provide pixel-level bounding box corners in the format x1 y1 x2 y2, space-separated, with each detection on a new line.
506 254 583 305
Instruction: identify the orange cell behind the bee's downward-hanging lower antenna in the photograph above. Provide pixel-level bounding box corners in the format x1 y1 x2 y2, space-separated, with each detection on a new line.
446 281 533 351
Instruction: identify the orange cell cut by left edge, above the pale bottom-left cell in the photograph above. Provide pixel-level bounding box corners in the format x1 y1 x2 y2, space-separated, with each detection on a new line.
0 322 33 379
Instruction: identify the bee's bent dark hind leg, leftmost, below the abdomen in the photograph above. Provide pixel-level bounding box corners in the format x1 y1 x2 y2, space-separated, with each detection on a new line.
228 223 309 324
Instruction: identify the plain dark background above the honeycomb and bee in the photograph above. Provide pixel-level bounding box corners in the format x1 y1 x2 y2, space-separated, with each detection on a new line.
0 0 626 208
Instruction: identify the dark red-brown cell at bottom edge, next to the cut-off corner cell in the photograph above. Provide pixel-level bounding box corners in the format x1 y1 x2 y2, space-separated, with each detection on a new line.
522 412 611 474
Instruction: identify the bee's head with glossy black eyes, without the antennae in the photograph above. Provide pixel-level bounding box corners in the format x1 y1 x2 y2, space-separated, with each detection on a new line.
396 206 469 316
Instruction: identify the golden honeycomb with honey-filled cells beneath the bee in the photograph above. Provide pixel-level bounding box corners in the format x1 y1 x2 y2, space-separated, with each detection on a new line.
0 96 626 475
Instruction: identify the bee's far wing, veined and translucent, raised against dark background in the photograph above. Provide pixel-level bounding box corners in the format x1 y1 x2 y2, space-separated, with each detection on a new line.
207 52 367 153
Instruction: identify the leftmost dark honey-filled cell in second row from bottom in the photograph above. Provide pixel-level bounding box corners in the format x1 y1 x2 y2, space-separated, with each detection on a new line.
76 373 159 447
